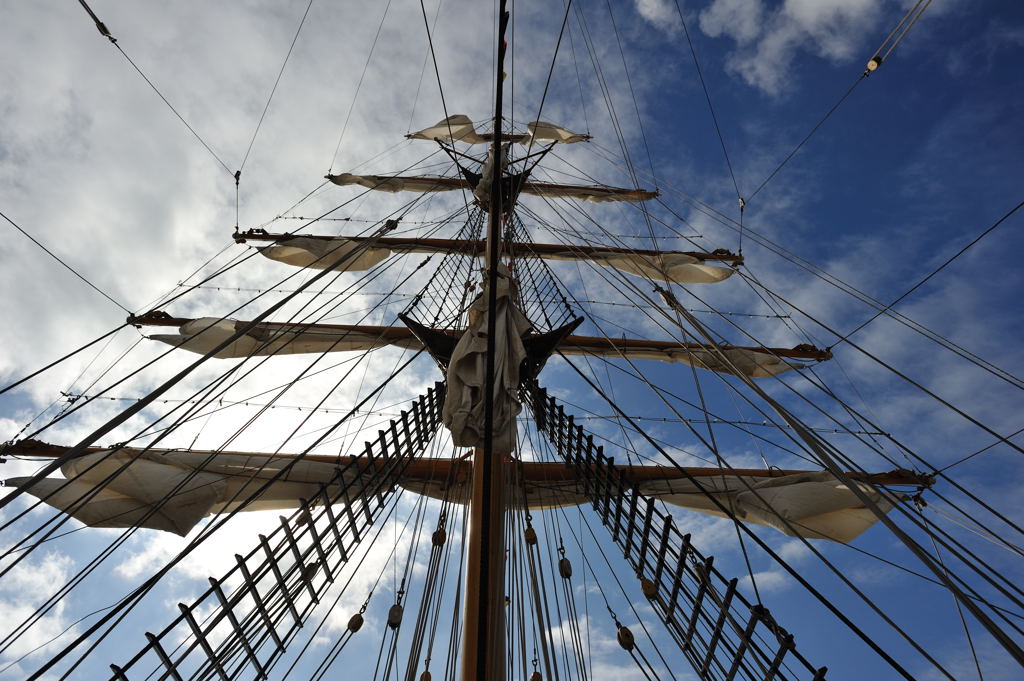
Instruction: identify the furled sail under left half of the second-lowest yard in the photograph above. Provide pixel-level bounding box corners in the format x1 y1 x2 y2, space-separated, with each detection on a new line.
150 316 420 359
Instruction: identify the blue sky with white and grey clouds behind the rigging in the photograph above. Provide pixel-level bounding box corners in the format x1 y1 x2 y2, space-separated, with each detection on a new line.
0 0 1024 679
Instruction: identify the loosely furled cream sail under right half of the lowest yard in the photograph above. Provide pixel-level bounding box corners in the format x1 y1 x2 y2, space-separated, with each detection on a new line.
639 471 893 543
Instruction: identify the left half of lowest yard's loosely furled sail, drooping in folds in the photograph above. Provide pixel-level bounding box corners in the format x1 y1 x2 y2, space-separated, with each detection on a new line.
7 449 368 536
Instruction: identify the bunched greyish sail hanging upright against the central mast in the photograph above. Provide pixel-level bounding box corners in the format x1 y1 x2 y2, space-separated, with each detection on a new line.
441 265 530 454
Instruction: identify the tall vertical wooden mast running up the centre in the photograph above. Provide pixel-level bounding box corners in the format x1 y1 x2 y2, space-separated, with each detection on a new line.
462 0 509 681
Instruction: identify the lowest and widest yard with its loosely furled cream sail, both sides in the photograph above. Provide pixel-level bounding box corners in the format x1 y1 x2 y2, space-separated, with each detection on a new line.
7 440 928 543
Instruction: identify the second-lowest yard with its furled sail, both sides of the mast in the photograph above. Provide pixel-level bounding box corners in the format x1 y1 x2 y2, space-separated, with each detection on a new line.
129 312 831 378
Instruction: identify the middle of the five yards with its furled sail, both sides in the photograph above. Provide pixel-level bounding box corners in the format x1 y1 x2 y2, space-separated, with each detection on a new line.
238 232 740 284
